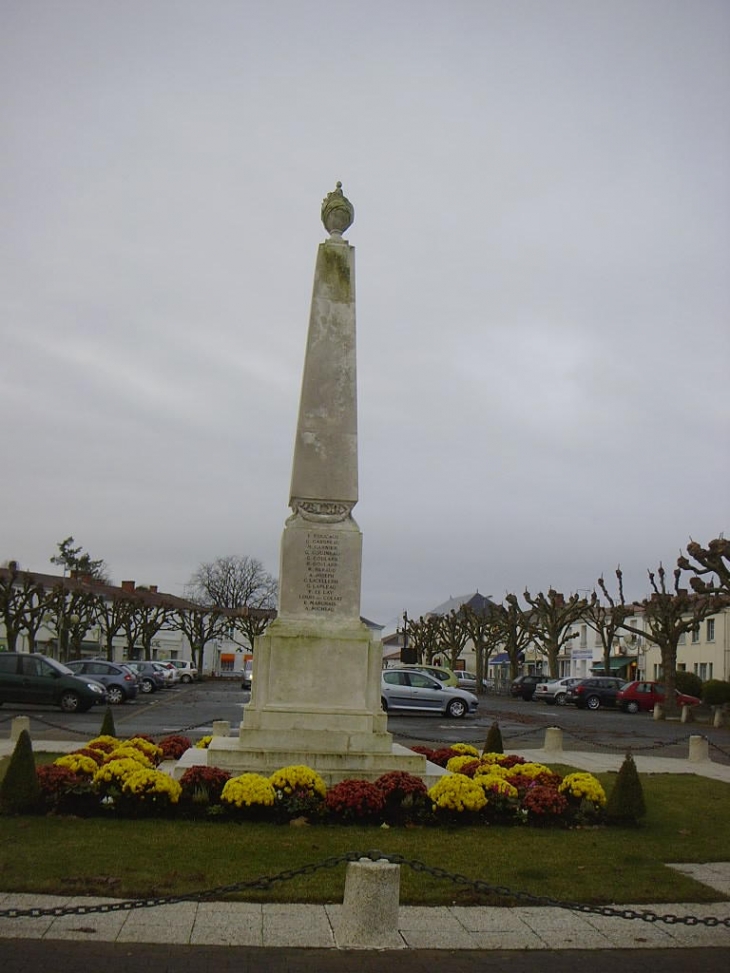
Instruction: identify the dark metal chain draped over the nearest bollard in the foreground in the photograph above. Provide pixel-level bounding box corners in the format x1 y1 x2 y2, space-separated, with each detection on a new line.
0 850 730 929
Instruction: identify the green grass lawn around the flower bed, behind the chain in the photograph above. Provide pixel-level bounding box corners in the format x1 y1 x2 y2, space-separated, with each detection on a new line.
0 754 730 905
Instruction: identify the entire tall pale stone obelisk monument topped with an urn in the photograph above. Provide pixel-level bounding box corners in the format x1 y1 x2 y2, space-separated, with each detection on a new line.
202 182 427 783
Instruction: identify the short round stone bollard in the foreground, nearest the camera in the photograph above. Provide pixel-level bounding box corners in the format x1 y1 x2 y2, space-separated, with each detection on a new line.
335 858 405 949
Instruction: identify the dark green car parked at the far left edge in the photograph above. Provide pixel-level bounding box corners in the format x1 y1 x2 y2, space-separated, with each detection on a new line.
0 652 106 713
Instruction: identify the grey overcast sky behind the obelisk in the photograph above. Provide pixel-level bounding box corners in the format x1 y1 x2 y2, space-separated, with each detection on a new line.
0 0 730 630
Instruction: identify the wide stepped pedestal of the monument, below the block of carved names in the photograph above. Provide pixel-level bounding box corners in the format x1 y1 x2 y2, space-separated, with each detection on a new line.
208 618 437 785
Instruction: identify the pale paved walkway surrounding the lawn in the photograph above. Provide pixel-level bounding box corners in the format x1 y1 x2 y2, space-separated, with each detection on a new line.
0 739 730 950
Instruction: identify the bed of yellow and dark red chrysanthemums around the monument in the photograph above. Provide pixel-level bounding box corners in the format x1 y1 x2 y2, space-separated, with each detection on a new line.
25 736 606 827
